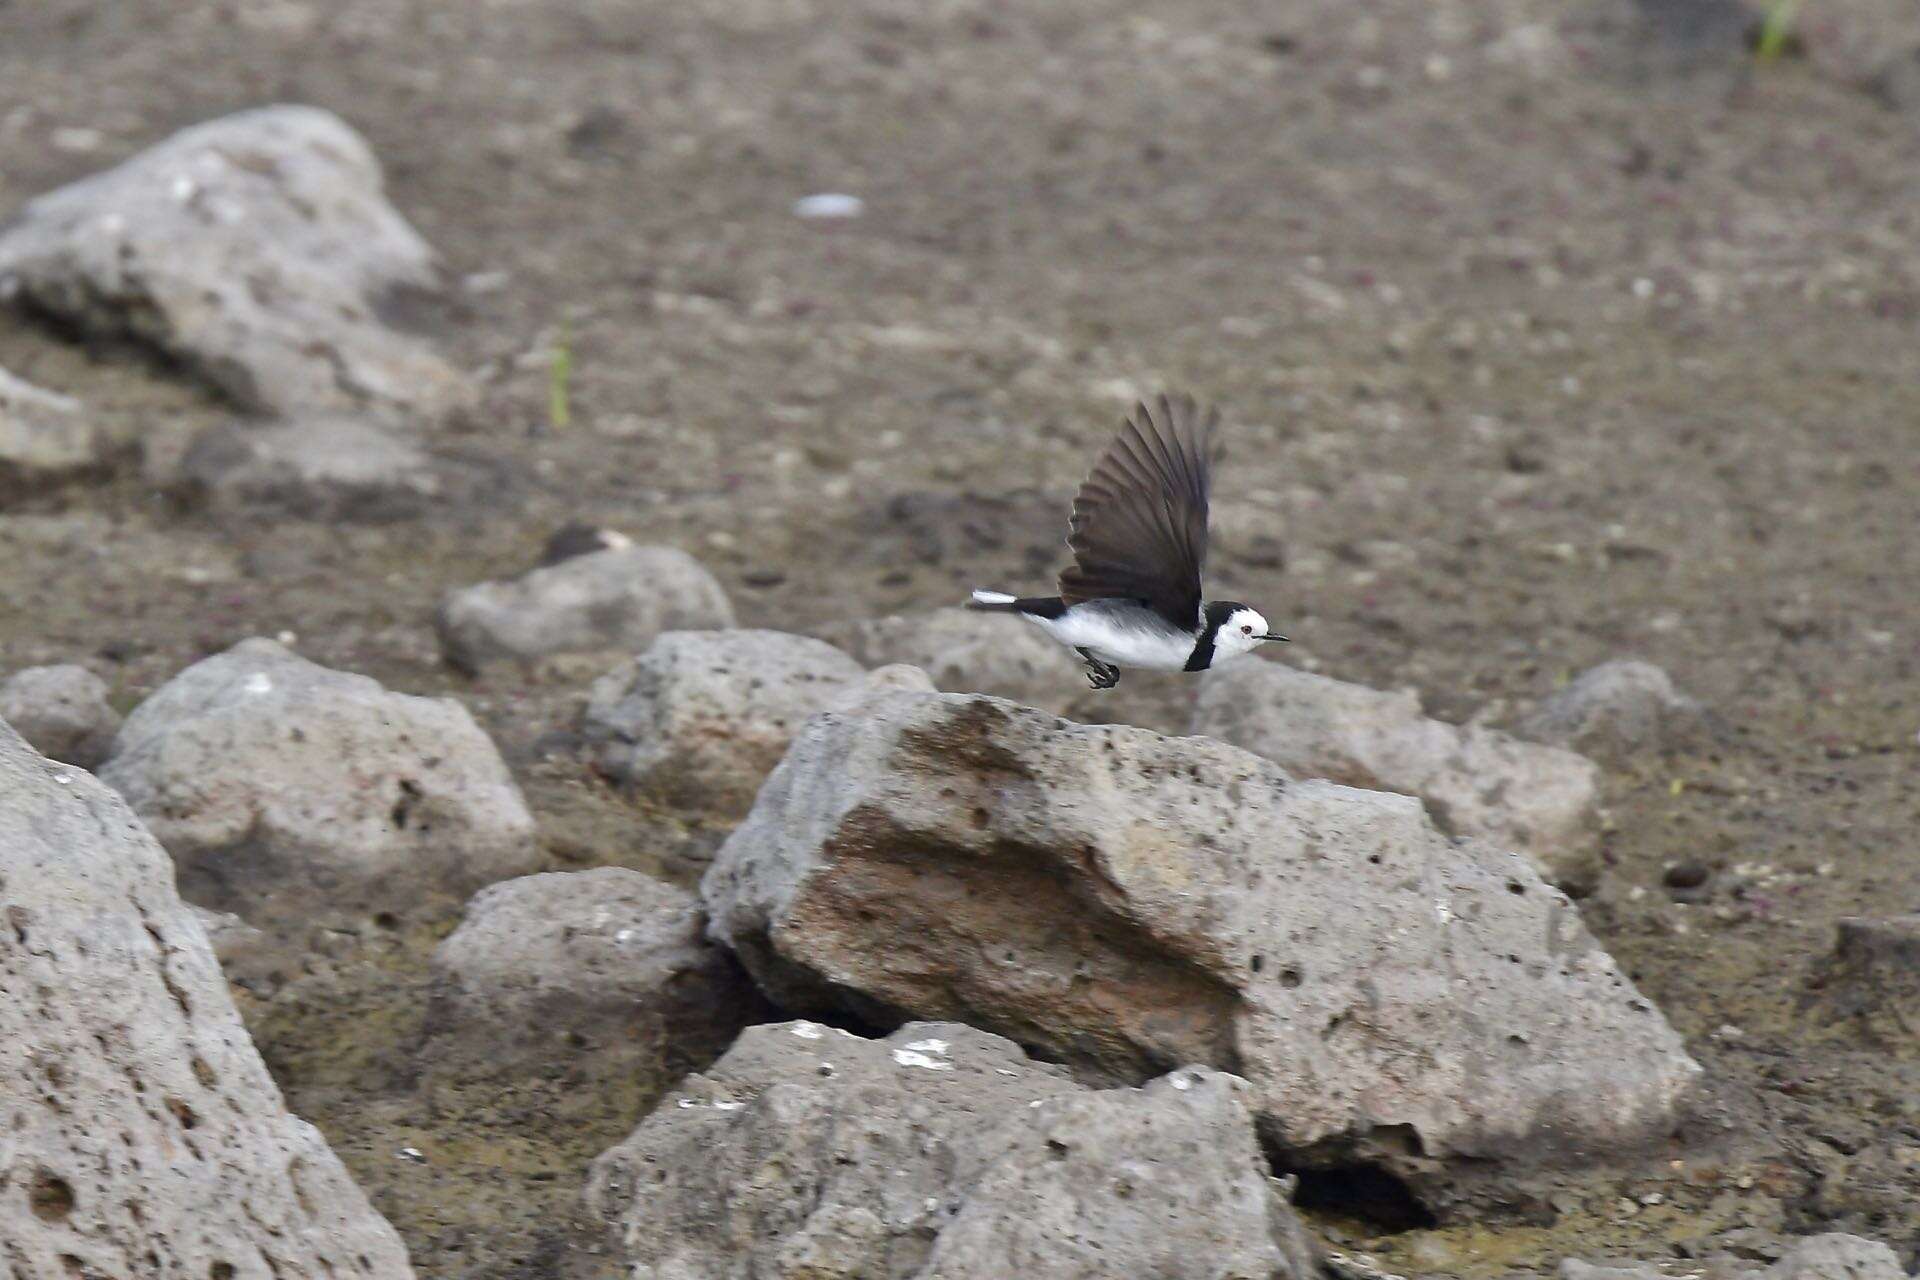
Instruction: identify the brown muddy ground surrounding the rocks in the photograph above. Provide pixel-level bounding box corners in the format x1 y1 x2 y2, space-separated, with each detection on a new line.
0 0 1920 1280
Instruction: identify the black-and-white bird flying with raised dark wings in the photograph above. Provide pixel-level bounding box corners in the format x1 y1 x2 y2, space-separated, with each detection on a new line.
968 395 1286 689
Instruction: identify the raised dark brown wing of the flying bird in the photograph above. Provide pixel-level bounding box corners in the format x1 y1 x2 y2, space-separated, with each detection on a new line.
1060 395 1219 631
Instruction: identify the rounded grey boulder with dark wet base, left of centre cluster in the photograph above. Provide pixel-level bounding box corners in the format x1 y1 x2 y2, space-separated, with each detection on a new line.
100 639 538 933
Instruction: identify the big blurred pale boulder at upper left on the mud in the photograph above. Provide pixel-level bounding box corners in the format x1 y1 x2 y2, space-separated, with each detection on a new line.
0 106 470 415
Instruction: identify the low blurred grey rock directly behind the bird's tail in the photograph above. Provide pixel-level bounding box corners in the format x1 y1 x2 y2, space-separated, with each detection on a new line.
826 608 1087 712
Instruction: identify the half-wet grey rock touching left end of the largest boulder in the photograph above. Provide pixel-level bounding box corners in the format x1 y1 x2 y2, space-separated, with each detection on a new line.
424 867 762 1077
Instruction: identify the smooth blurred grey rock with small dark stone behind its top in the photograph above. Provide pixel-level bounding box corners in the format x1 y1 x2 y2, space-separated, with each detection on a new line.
434 547 733 672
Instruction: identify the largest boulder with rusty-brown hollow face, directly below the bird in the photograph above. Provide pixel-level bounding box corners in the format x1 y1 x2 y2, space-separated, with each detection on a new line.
701 693 1699 1211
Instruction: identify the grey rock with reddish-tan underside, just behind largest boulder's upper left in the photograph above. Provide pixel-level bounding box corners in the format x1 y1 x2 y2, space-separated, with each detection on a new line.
582 631 866 818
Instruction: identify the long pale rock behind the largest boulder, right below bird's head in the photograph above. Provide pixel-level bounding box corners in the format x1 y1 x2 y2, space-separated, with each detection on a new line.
1192 658 1599 887
